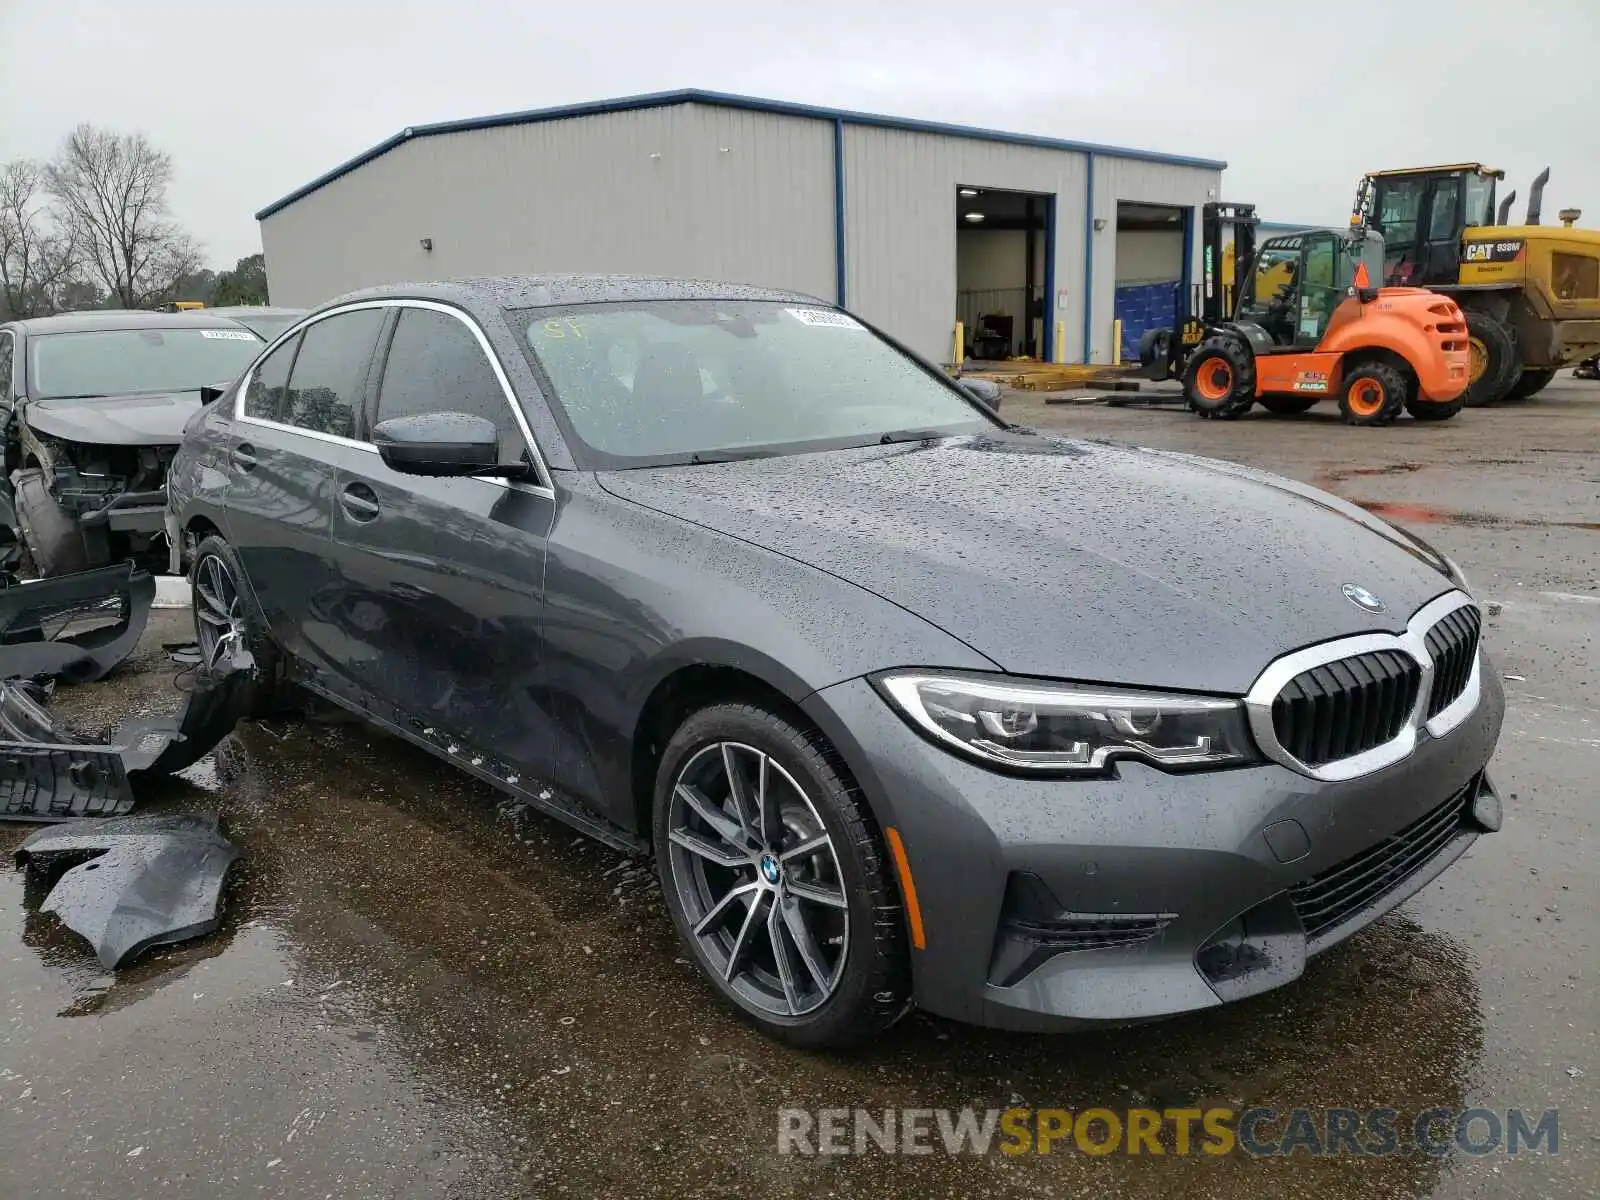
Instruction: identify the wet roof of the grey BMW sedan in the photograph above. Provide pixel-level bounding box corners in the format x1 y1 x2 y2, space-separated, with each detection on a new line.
322 274 827 321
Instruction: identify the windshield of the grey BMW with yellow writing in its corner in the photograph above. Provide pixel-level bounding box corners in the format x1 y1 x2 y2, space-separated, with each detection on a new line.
512 301 997 467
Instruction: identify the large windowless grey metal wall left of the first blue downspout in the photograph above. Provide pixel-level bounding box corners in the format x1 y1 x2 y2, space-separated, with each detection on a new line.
261 104 838 304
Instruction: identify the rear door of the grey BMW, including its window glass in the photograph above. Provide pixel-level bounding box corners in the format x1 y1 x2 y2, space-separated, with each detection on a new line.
226 306 387 670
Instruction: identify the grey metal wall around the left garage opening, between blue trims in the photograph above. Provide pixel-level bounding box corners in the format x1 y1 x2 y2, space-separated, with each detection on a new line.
845 125 1110 362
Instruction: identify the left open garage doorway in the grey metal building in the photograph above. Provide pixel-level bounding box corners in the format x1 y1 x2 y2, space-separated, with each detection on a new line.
955 186 1053 358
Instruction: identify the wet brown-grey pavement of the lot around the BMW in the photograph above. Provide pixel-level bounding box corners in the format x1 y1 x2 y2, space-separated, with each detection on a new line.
0 382 1600 1198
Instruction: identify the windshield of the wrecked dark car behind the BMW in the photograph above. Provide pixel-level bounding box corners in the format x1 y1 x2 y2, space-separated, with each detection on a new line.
27 326 262 400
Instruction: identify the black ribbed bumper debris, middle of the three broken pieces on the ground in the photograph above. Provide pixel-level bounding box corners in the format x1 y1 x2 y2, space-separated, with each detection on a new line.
0 643 256 821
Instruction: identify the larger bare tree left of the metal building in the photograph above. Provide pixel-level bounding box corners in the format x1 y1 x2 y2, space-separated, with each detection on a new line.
46 125 200 309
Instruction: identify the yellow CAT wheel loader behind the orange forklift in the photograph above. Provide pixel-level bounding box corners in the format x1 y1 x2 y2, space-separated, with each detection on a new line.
1350 163 1600 406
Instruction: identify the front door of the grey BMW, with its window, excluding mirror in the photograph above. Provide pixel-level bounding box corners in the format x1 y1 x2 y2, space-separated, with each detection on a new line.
324 302 555 778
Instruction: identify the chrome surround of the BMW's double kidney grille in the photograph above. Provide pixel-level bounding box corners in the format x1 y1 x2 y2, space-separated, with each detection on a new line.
1245 590 1483 782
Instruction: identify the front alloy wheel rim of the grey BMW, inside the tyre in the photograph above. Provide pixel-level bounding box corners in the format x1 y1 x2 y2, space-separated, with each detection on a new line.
667 741 850 1018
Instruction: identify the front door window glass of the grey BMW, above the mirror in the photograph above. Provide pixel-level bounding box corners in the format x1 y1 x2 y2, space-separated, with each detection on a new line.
378 309 522 453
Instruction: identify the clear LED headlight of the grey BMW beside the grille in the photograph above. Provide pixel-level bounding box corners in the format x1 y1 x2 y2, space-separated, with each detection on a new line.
875 670 1258 774
